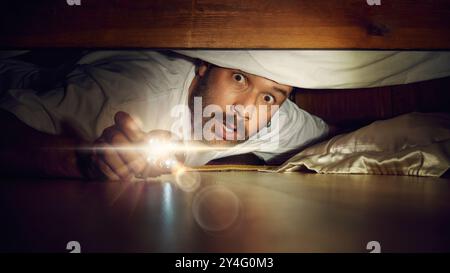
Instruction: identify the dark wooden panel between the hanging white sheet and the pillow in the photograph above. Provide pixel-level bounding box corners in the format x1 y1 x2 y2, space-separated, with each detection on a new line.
294 77 450 130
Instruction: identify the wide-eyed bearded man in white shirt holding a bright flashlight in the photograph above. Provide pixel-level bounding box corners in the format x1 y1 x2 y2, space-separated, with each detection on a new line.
0 51 328 180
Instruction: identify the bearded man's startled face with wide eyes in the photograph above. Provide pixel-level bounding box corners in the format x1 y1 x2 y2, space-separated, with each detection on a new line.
189 64 292 146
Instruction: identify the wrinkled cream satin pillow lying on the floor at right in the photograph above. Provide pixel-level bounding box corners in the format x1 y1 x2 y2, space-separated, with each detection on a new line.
277 113 450 176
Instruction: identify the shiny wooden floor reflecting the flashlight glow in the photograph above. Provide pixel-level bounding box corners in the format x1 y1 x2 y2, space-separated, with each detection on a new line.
0 172 450 252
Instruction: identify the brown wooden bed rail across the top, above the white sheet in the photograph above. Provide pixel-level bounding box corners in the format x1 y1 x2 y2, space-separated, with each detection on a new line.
0 0 450 49
